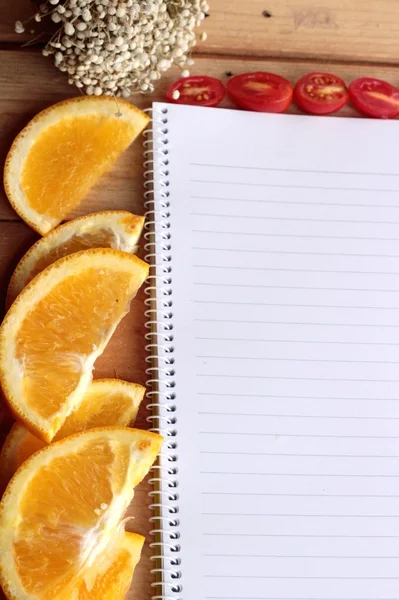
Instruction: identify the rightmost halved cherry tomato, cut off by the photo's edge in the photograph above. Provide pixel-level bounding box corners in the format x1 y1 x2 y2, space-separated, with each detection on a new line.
348 77 399 119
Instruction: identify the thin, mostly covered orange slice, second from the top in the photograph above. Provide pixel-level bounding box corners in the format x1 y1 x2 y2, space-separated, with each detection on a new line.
7 210 144 306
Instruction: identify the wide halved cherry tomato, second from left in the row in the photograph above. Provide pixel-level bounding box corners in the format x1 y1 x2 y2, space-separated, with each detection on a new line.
226 71 293 113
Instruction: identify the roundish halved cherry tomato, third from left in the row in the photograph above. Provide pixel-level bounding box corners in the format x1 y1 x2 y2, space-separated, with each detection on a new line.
294 71 348 115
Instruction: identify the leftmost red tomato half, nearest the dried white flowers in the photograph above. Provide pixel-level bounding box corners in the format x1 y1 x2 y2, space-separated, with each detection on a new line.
166 75 226 106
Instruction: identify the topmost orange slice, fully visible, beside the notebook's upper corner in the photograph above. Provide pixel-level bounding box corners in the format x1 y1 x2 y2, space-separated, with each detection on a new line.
4 96 149 235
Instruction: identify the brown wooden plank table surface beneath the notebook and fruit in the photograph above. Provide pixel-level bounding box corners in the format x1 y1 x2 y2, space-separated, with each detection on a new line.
0 0 399 600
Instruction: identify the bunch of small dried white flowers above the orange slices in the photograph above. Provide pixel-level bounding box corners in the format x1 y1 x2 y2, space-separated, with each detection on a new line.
15 0 209 97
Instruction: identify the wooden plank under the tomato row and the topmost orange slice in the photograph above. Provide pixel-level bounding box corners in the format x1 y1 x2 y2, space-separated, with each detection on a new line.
0 50 399 220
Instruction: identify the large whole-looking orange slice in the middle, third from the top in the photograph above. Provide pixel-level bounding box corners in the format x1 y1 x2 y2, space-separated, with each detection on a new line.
0 248 148 442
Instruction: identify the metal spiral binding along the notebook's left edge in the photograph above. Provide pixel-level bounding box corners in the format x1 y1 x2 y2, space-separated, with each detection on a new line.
144 107 183 600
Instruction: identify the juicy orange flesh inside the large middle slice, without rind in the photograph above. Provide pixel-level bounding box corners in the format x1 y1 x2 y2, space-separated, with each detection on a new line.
16 268 132 418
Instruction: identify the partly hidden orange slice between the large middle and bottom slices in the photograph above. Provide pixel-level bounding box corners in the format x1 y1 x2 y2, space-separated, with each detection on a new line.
0 379 145 494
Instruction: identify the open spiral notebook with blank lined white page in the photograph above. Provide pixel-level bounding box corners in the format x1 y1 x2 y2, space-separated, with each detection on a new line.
145 103 399 600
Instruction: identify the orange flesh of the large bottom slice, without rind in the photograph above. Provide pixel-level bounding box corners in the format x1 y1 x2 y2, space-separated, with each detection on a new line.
13 440 116 600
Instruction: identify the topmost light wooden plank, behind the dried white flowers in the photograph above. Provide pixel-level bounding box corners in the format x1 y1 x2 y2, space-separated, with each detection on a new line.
0 0 399 64
